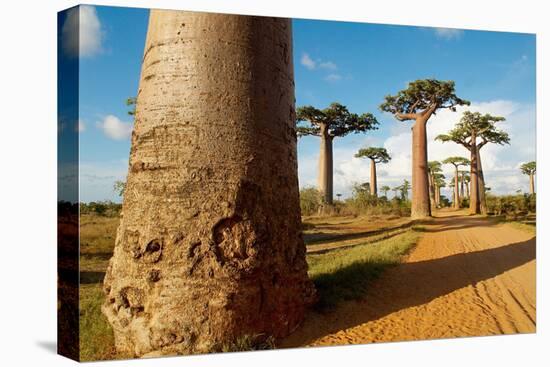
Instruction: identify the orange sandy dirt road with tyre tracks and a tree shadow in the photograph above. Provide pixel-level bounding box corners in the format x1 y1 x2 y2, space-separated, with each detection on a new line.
281 212 536 347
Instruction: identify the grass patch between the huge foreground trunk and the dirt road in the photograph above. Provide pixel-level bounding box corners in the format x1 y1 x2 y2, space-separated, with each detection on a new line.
307 227 420 311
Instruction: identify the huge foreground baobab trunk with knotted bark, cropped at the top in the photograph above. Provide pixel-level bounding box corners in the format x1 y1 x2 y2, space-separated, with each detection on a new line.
102 10 314 356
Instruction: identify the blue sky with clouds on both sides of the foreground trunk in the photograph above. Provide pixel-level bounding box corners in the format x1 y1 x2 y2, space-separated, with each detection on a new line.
62 7 535 201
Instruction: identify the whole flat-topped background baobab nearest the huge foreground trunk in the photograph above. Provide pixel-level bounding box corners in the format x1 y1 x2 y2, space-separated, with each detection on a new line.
296 102 378 205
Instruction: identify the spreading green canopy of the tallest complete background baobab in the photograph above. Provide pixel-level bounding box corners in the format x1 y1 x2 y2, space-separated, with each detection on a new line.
380 79 470 121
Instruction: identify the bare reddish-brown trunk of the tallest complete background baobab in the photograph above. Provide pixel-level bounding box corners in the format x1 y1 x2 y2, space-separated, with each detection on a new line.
411 118 431 219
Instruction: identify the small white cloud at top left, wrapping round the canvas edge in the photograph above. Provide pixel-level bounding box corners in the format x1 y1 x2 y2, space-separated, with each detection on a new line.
61 5 103 57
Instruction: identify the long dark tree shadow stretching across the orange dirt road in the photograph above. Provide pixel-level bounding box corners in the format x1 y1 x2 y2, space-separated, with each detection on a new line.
281 238 536 347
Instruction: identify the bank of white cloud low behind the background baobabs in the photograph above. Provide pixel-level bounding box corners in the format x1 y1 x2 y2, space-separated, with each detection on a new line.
298 101 536 197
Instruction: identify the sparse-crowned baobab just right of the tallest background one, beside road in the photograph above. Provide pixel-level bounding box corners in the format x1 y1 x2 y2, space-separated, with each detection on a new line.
436 111 510 214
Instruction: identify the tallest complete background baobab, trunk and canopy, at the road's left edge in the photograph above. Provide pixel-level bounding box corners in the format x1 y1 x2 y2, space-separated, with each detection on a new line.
380 79 470 218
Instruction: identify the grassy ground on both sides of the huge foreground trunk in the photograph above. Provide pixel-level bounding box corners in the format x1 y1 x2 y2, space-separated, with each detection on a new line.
80 215 422 361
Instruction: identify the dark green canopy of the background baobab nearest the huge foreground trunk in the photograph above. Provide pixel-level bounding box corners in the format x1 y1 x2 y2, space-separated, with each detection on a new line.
296 102 378 138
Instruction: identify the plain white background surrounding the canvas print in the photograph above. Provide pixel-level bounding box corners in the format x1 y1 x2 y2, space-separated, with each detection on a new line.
0 0 550 367
